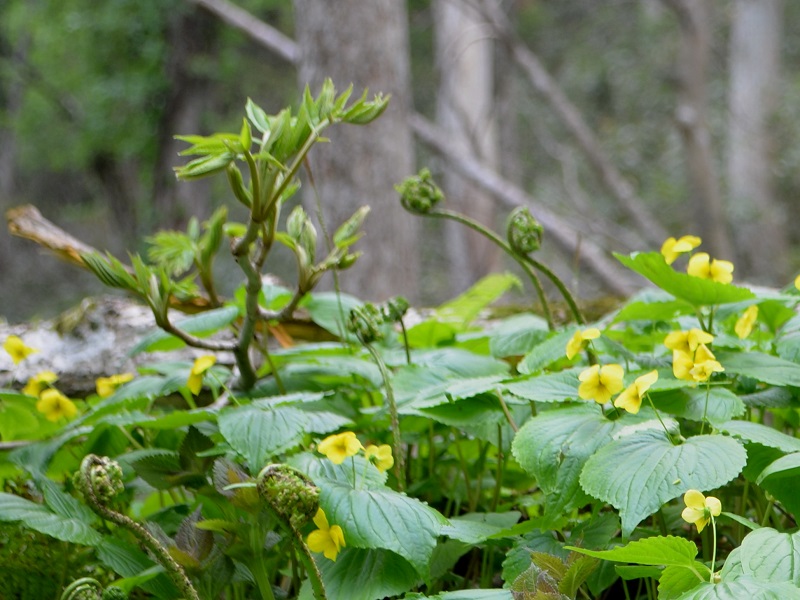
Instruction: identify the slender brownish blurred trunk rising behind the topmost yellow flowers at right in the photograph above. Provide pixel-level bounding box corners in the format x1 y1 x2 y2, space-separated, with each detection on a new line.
665 0 735 259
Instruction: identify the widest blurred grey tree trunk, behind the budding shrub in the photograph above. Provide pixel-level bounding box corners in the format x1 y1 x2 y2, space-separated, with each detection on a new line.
294 0 419 300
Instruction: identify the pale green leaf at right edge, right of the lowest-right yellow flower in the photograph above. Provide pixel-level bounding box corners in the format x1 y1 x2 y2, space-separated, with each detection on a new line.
739 527 800 594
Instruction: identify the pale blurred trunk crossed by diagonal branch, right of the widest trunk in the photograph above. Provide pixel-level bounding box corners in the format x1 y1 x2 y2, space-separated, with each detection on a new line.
434 0 501 290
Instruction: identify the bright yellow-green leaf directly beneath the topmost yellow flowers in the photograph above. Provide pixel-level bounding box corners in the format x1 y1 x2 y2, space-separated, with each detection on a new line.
614 252 756 308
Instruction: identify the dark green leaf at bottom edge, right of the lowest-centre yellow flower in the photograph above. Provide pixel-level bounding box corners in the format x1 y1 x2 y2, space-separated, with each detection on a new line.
316 540 420 600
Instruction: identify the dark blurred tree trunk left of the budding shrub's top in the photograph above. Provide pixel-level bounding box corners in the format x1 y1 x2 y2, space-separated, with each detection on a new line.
147 10 219 228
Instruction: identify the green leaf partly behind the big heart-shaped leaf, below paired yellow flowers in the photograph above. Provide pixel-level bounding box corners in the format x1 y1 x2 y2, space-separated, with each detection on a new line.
511 404 624 517
